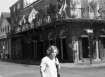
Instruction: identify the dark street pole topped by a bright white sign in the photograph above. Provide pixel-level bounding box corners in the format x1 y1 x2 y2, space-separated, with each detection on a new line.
86 29 93 64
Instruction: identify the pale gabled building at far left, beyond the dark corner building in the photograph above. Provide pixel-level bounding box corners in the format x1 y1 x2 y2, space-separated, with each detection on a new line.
0 12 11 58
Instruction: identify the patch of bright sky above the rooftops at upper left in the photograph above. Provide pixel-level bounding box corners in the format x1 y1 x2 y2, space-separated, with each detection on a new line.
0 0 18 14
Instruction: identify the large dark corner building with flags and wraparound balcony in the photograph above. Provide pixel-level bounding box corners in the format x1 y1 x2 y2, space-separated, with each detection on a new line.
10 0 105 62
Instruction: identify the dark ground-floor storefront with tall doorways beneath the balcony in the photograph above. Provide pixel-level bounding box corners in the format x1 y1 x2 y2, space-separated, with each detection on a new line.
12 19 105 63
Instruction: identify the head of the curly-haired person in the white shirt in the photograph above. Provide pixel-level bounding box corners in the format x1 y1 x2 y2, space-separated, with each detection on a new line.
47 45 58 57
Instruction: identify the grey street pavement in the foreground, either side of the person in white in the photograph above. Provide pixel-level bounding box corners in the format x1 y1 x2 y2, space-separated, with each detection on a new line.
0 61 105 77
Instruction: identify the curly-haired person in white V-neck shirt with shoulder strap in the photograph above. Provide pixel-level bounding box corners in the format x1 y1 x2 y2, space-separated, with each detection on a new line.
40 45 60 77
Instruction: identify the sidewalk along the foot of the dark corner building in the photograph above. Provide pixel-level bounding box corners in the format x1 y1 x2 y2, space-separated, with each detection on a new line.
0 59 105 68
